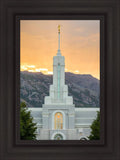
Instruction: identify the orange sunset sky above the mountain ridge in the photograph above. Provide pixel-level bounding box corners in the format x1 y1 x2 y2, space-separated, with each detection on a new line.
20 20 100 79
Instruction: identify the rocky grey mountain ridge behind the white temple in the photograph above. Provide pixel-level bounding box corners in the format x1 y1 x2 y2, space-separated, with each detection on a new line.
20 71 100 107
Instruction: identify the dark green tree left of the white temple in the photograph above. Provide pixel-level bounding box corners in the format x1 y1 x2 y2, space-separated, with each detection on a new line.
20 102 37 140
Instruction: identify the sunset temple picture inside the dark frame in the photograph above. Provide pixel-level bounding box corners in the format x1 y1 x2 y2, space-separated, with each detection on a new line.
20 20 100 140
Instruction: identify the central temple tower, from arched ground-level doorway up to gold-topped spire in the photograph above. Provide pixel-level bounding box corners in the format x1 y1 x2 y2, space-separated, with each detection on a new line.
42 25 75 139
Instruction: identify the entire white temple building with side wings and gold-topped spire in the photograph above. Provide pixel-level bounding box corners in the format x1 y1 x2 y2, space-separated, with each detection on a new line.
29 26 99 140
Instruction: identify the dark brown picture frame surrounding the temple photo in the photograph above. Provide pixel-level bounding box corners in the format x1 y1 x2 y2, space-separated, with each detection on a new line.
0 0 120 160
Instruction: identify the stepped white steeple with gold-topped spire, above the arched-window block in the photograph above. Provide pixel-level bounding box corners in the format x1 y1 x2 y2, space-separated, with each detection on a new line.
45 25 73 105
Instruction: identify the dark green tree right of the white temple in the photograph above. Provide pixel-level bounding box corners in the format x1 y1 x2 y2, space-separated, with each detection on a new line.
88 111 100 140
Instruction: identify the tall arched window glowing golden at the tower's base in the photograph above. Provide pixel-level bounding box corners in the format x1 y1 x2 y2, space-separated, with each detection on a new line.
54 112 63 129
